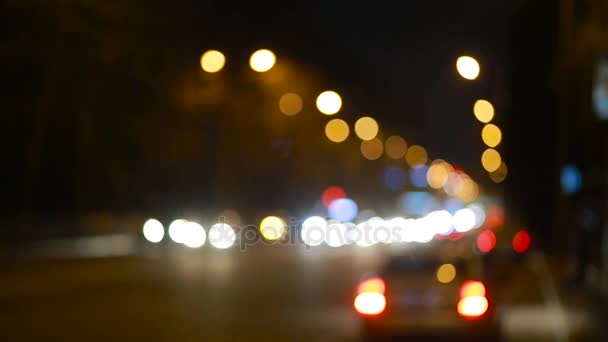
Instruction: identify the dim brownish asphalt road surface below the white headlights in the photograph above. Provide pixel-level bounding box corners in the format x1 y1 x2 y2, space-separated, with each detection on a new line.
0 238 596 341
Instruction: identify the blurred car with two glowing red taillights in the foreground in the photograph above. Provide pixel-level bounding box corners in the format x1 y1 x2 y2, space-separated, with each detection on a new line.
353 251 501 341
